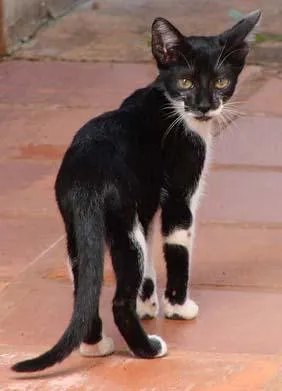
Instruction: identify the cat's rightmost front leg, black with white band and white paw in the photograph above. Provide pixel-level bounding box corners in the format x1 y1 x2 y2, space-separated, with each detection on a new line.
162 196 199 319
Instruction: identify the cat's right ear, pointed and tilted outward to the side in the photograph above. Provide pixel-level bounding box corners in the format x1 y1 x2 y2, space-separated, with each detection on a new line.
219 10 261 48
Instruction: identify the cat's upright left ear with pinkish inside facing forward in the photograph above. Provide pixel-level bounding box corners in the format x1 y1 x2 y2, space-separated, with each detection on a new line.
152 18 183 65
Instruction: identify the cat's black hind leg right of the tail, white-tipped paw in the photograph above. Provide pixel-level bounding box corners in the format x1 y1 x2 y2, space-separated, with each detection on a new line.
109 219 167 358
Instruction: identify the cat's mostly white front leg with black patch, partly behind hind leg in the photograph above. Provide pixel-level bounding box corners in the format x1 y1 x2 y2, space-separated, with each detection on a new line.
136 214 159 319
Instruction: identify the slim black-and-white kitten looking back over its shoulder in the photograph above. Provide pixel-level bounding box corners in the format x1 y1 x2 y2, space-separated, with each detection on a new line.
12 11 260 372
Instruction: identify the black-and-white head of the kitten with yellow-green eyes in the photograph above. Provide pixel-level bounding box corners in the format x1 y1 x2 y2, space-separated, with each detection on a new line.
152 10 261 121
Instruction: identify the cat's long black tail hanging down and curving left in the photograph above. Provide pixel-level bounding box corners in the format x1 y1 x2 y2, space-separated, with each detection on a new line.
11 206 104 372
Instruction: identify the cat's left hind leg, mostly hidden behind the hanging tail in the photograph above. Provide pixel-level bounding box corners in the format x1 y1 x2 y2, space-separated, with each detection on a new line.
67 225 114 357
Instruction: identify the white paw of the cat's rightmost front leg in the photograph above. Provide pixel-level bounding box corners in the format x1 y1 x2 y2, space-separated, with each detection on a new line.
164 298 199 320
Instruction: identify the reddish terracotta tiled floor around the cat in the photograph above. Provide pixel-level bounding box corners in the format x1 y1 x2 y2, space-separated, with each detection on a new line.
0 2 282 391
